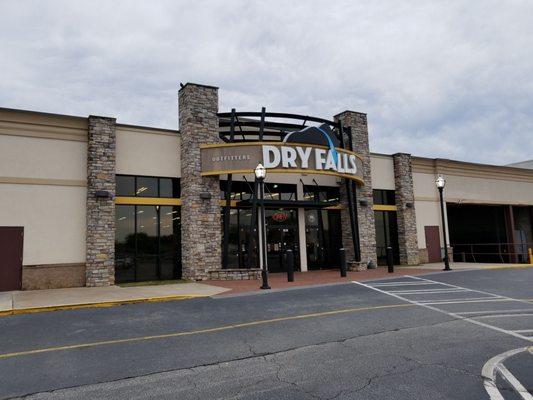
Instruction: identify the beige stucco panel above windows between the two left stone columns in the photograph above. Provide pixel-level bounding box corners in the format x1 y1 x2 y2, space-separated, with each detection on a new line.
116 125 181 177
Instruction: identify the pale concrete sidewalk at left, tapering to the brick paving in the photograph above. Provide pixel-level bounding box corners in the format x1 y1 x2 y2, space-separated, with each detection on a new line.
0 283 229 315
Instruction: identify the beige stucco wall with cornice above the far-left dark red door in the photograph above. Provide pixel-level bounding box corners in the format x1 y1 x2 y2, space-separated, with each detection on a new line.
0 109 87 265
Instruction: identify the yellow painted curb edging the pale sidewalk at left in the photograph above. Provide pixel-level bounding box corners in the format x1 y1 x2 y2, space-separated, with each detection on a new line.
0 295 209 317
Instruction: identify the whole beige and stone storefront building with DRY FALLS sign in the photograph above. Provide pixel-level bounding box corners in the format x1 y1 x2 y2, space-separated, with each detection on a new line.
0 84 533 290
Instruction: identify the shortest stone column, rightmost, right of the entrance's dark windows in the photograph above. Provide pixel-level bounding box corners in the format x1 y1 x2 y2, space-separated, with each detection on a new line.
392 153 420 265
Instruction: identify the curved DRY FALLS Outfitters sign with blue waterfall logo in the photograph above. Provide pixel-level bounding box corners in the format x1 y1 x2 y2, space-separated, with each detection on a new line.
200 125 363 183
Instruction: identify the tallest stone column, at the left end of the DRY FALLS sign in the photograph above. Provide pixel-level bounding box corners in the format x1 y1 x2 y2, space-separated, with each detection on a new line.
178 83 222 280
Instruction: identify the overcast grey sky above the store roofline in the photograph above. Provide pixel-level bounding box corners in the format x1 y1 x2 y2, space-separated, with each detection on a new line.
0 0 533 164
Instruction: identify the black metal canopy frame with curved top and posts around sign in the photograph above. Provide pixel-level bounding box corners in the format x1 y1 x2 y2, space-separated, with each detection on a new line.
217 107 361 269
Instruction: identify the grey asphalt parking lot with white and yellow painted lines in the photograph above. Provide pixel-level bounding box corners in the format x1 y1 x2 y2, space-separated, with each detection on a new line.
0 269 533 399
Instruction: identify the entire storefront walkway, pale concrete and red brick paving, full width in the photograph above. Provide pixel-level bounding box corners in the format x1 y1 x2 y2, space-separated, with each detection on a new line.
0 263 532 316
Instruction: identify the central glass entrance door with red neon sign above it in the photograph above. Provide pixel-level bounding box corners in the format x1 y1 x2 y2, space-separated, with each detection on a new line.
266 209 300 272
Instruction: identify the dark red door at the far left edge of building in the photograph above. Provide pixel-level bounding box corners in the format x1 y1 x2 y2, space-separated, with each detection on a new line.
0 226 24 292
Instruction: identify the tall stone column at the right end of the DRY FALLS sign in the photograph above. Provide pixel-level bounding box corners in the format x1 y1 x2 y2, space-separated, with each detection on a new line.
334 111 377 267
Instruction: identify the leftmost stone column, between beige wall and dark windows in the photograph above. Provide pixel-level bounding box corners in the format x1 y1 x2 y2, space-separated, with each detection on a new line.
85 115 116 286
